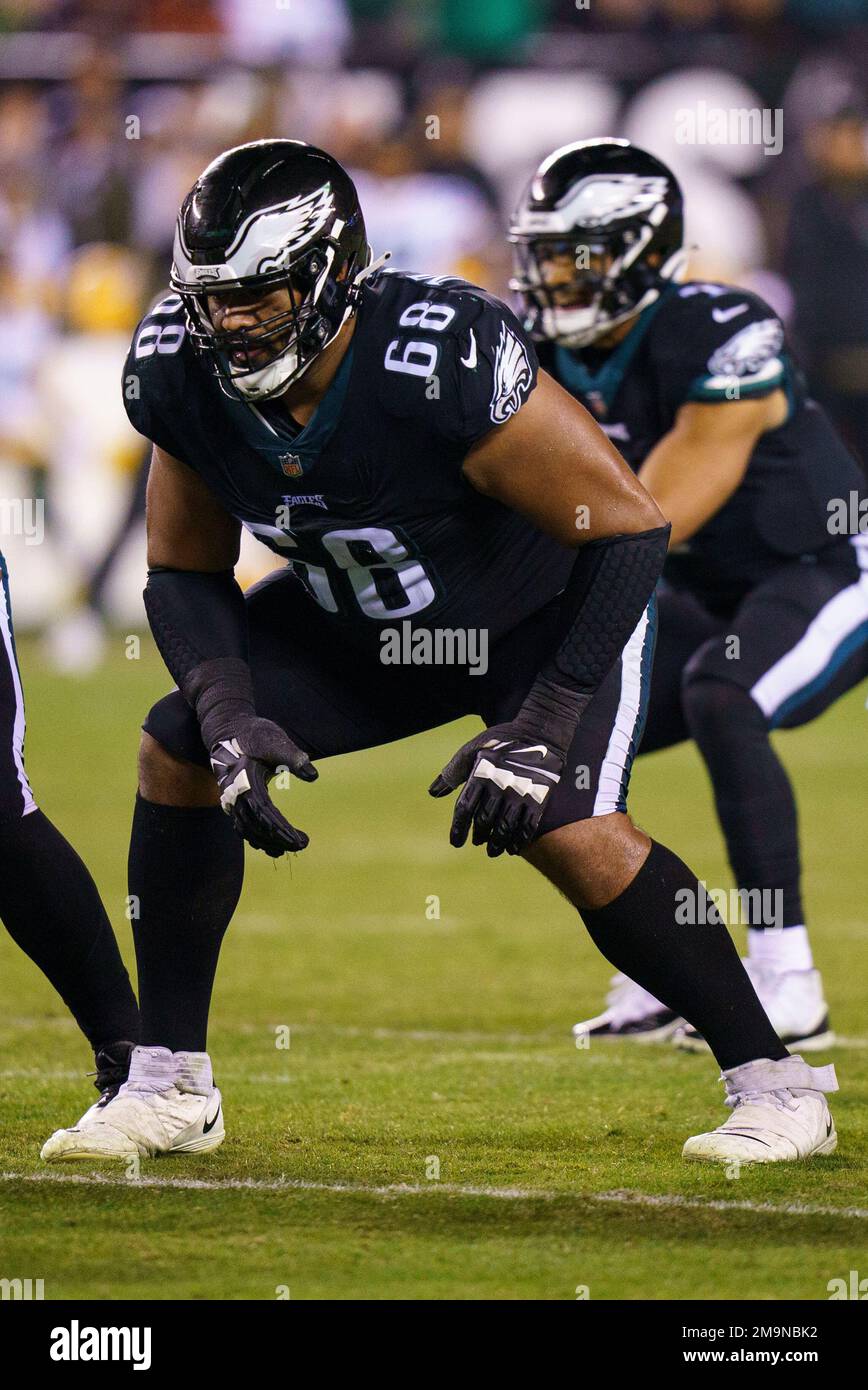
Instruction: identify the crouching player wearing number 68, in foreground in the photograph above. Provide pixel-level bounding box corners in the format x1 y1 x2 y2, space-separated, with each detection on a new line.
46 140 836 1161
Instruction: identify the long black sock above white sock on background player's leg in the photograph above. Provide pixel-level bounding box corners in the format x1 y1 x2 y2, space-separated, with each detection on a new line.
683 676 804 927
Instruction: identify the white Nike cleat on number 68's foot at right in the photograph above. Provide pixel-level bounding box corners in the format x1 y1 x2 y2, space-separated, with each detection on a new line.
682 1056 837 1163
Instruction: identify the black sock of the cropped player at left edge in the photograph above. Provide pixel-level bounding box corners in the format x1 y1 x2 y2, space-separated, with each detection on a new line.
0 810 139 1051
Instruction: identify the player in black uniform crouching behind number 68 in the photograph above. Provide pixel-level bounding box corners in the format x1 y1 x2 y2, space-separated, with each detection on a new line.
511 140 868 1049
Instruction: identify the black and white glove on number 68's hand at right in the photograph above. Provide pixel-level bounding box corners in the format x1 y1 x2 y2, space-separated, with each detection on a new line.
428 724 566 859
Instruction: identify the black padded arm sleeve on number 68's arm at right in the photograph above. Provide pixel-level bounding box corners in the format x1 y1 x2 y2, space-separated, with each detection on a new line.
517 525 670 752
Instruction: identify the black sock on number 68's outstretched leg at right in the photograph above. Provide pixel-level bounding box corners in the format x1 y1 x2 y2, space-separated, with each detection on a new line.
581 841 787 1070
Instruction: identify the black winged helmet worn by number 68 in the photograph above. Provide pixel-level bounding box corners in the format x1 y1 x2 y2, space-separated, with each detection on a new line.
171 140 370 402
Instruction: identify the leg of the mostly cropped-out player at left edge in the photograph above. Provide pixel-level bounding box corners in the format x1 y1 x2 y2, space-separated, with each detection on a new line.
0 555 139 1111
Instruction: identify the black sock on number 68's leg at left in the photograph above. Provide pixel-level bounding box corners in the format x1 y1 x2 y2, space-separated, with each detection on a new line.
129 796 243 1052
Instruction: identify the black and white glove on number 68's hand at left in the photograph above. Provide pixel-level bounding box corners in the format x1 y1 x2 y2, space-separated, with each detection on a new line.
210 714 320 859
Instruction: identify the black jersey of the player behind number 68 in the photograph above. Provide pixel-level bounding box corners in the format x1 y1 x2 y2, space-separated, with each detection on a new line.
538 282 864 607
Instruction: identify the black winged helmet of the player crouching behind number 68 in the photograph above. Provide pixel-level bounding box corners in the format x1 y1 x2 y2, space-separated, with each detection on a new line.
509 140 687 348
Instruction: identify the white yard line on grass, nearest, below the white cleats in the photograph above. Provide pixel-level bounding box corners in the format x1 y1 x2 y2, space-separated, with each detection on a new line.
0 1173 868 1220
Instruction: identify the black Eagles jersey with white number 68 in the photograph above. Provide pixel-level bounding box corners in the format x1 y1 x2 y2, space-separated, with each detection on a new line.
124 271 574 641
